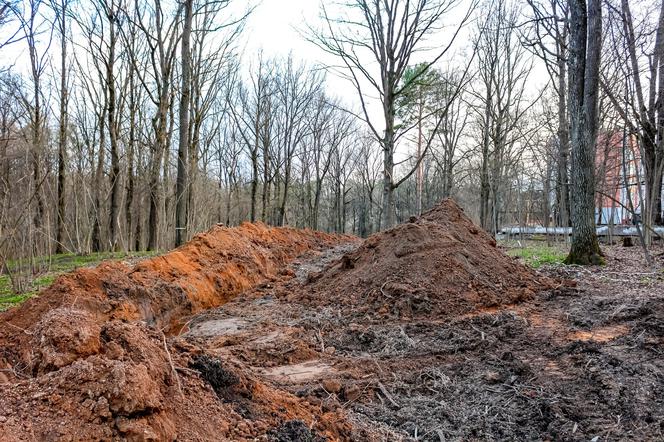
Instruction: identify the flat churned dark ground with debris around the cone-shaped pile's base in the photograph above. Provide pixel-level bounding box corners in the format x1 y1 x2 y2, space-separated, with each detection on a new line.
183 246 664 441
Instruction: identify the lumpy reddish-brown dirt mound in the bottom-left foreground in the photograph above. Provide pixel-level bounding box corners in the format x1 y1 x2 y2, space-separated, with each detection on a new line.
0 320 348 441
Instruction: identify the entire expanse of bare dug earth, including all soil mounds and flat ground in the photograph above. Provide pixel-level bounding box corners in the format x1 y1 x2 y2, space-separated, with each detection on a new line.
0 200 664 441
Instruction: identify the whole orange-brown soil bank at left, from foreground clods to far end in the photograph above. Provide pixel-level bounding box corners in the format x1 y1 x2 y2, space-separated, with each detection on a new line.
0 224 350 441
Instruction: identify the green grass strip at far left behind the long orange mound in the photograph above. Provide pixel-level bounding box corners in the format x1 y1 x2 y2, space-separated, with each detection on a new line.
0 252 158 311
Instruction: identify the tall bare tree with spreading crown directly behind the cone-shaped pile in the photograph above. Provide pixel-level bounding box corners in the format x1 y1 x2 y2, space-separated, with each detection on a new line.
311 0 476 228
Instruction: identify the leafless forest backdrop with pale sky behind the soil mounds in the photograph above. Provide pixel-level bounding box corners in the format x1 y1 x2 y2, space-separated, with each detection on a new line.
0 0 664 264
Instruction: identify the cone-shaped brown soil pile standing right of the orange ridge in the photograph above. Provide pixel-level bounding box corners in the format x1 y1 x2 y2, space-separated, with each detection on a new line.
301 199 551 318
